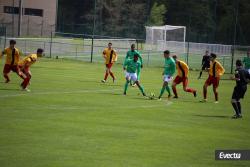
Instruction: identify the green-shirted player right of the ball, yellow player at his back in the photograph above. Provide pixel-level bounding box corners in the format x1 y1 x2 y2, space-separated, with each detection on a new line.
158 50 176 99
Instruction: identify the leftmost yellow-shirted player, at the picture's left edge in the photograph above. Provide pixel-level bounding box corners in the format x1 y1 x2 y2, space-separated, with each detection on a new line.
2 40 25 83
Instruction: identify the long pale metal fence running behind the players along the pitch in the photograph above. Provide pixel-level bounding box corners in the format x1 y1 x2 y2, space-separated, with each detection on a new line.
0 32 249 73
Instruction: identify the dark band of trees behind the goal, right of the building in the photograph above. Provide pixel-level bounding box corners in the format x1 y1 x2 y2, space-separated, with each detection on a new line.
57 0 250 45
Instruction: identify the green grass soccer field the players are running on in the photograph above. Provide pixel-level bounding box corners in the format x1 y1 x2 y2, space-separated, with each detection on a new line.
0 58 250 167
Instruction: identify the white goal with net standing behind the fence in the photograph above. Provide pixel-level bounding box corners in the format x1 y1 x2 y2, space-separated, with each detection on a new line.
146 25 186 54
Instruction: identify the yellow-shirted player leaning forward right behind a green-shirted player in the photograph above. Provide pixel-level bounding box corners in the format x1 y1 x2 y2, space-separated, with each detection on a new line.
172 55 196 98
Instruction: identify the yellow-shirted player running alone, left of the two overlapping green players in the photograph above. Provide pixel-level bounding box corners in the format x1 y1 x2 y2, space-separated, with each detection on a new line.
102 42 117 83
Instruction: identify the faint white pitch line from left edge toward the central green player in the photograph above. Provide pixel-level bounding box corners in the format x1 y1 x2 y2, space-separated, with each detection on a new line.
0 89 121 98
